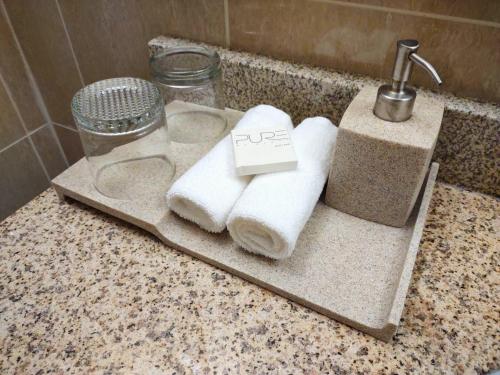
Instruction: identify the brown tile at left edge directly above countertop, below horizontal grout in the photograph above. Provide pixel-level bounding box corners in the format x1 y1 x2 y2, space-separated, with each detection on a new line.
0 139 49 220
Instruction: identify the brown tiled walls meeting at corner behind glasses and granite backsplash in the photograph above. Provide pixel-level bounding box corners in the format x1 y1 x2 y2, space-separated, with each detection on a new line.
0 0 500 219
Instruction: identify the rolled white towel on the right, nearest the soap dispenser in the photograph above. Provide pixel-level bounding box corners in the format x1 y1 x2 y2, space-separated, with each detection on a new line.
227 117 337 259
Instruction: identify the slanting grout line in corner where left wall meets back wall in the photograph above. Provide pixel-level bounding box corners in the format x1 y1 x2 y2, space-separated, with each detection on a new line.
0 0 69 169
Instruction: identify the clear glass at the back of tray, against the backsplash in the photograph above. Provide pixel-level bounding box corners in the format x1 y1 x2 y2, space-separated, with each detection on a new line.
150 47 227 143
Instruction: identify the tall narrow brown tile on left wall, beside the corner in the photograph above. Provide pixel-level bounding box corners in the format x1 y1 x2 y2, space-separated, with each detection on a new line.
0 9 45 130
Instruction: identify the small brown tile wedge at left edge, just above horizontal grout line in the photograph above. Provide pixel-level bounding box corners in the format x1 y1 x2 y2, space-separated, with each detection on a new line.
0 82 26 150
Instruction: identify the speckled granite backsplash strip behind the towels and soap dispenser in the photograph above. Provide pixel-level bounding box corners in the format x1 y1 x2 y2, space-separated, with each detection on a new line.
149 37 500 196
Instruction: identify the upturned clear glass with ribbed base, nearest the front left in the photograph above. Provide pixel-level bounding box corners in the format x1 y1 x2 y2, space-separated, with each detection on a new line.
71 78 175 200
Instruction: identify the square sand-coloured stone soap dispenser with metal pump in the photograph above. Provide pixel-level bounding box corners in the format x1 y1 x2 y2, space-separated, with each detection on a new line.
325 40 444 227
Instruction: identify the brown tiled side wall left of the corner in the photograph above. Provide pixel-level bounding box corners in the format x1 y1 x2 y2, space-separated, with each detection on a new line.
0 4 68 220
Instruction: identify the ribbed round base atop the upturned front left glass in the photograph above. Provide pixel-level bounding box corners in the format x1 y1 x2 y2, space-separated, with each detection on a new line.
71 77 164 135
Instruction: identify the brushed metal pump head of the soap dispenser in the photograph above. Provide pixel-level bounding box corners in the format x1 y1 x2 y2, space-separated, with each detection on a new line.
373 39 443 122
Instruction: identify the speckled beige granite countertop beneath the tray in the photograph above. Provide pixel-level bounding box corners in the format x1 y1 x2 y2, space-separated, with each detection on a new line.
0 183 500 374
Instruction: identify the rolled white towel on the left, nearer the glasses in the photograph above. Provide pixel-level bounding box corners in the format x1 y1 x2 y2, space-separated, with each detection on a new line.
167 104 293 233
